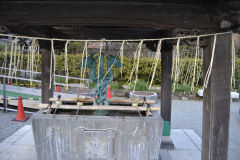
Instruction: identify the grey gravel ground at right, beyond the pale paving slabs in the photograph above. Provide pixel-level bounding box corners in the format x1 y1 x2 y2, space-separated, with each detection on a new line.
172 100 240 160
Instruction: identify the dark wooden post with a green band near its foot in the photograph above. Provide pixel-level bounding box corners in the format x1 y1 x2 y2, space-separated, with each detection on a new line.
161 43 173 136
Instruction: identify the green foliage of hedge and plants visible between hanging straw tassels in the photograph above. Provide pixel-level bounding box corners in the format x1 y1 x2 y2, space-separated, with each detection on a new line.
0 50 240 92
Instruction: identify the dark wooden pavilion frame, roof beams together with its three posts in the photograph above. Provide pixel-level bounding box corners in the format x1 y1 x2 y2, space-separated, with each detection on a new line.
0 0 240 160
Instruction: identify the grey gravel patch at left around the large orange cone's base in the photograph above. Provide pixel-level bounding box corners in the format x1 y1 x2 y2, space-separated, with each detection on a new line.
0 110 31 142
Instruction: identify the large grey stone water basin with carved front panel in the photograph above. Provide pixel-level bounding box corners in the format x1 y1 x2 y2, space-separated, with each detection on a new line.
32 110 163 160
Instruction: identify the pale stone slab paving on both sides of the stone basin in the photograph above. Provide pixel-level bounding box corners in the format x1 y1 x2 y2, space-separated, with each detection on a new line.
0 125 201 160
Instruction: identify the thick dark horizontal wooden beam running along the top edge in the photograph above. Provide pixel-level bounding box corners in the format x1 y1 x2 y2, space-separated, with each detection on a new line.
0 0 212 30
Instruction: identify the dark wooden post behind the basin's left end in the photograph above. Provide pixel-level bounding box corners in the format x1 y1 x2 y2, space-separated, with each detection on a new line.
39 41 54 103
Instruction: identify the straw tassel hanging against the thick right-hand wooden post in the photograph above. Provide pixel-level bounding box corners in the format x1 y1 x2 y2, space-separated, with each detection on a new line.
203 34 217 91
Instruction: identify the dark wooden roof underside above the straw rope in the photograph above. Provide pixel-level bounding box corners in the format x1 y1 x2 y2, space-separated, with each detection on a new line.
0 0 240 39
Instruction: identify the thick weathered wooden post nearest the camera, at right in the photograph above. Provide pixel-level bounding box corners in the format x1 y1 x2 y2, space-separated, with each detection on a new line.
202 34 232 160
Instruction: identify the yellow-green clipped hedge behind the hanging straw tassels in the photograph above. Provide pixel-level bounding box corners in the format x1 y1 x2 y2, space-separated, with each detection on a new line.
0 53 240 89
